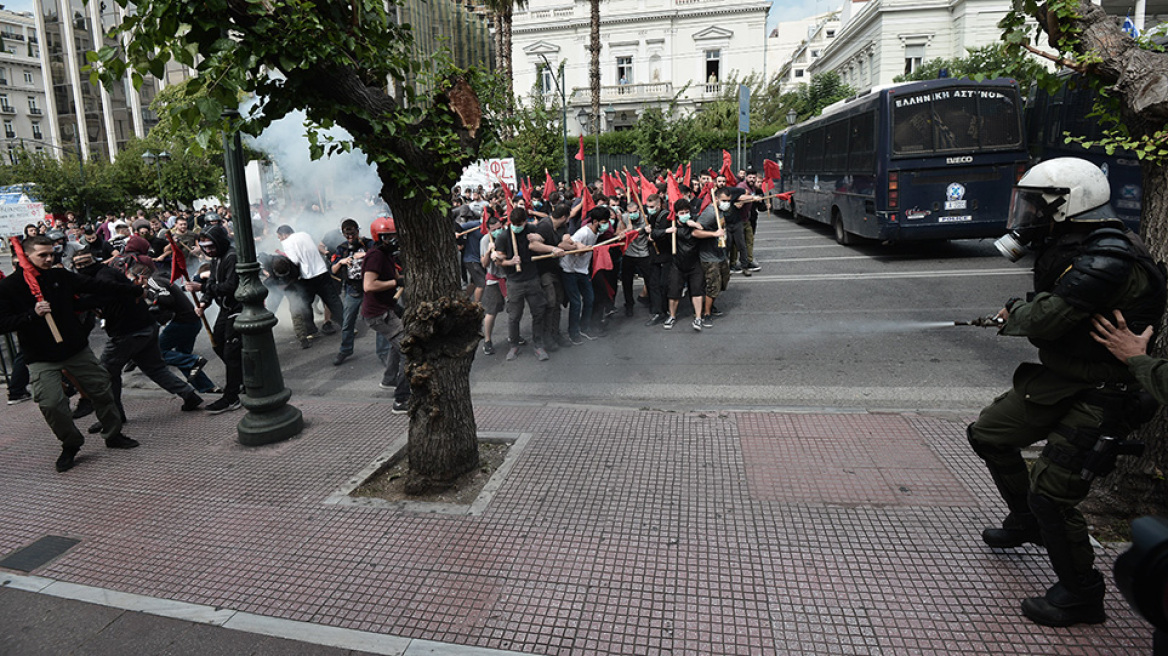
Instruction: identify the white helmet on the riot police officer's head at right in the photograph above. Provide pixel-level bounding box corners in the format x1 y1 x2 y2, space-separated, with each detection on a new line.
1006 158 1115 230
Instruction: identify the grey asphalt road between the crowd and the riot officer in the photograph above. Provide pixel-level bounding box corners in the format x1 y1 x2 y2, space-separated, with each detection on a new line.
123 216 1035 413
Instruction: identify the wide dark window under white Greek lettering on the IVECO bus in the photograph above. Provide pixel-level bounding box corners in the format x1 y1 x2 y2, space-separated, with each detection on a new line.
892 89 1022 156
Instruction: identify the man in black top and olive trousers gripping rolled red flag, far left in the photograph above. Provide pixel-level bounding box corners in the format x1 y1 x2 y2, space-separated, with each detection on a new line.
0 236 142 472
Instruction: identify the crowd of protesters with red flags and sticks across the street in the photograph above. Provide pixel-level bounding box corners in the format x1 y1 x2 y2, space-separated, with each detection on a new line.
0 162 765 472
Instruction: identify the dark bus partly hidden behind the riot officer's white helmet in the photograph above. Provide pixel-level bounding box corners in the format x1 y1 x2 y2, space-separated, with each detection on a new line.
1027 74 1143 232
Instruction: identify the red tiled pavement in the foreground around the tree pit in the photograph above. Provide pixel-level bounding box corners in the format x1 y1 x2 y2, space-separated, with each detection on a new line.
0 397 1150 655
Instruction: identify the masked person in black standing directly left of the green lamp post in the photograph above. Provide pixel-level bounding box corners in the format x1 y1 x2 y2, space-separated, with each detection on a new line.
186 223 243 414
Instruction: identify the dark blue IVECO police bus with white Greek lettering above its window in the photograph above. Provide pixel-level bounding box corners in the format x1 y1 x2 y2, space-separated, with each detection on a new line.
779 79 1028 244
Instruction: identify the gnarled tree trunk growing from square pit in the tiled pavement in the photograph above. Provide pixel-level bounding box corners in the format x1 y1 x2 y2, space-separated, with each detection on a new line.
382 175 482 494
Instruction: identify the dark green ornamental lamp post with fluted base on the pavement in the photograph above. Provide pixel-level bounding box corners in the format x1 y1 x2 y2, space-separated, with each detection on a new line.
223 111 304 446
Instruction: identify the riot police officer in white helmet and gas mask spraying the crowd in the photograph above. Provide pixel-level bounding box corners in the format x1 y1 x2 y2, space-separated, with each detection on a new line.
967 158 1166 627
